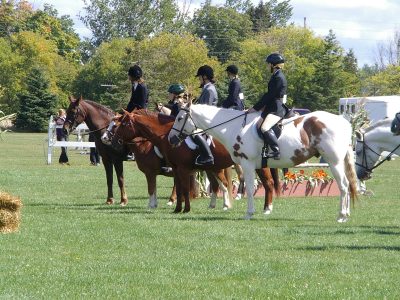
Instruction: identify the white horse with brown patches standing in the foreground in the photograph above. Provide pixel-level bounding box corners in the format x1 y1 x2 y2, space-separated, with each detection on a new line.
168 103 357 222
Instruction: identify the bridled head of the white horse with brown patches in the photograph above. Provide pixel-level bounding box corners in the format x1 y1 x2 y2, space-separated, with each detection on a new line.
168 102 197 147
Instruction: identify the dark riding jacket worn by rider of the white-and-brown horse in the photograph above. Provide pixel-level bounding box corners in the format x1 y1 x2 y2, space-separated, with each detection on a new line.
253 69 287 118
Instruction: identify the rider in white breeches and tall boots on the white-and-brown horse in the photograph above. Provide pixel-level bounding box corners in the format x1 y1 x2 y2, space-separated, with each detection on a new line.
248 53 287 159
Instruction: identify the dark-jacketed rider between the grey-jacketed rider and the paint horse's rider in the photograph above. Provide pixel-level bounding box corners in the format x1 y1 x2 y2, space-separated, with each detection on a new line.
222 65 244 110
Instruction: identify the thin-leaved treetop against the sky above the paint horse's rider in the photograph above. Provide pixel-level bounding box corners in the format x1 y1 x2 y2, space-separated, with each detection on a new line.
246 0 293 32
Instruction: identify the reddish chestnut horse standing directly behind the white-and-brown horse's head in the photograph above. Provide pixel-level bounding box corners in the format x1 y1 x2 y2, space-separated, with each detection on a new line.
108 111 279 213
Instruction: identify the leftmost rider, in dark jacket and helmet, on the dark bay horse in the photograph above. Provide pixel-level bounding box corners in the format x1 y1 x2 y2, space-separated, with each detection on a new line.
126 65 149 112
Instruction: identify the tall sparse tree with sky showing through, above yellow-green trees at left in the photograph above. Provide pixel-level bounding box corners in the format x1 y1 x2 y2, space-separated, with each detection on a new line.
81 0 186 46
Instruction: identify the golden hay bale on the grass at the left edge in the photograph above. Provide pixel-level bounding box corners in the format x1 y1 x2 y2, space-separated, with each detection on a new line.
0 191 22 233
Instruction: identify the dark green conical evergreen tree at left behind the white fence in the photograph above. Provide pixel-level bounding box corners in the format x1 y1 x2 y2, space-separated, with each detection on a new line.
15 67 57 132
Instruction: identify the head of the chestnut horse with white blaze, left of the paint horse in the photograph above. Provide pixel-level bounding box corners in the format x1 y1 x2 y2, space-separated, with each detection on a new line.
111 111 137 150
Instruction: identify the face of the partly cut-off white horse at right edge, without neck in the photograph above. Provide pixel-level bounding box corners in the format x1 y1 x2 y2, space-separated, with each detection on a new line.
355 131 380 180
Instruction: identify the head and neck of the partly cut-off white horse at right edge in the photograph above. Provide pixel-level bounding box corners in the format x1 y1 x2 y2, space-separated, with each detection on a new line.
356 119 400 180
